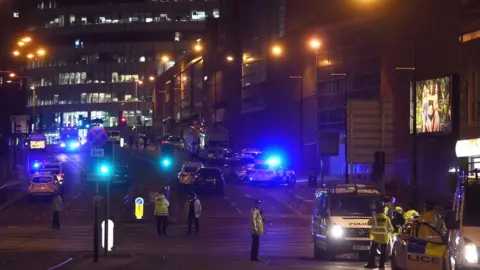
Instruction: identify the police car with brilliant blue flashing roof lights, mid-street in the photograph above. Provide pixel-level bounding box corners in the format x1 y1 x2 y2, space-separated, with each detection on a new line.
246 158 297 185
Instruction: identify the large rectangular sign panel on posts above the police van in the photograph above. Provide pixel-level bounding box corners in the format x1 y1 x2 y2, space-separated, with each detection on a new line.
347 100 393 164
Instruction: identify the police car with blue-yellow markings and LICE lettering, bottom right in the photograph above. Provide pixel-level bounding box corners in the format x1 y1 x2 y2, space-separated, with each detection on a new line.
392 221 450 270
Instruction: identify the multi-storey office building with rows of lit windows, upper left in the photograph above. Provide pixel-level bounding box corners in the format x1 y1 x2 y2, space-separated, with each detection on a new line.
25 0 220 129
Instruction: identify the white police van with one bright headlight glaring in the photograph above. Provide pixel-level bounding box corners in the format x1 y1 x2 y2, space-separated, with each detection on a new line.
312 184 383 260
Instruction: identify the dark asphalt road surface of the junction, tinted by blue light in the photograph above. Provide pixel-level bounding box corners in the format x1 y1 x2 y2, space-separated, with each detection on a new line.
0 144 386 270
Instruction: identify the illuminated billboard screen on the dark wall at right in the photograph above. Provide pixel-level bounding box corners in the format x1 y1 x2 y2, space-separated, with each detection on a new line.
410 76 452 133
